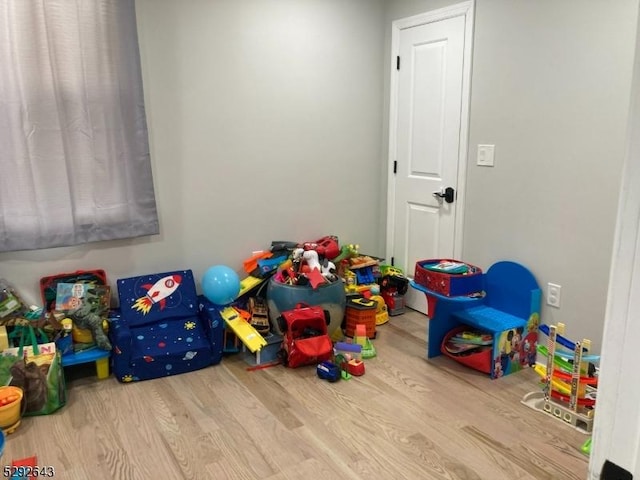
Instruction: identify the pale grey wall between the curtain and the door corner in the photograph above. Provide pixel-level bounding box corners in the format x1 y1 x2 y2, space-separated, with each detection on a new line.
0 0 384 303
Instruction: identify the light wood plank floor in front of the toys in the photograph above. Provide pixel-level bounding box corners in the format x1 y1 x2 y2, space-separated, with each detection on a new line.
1 312 588 480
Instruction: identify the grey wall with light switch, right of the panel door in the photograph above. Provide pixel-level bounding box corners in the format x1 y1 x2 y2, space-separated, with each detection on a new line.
383 0 638 351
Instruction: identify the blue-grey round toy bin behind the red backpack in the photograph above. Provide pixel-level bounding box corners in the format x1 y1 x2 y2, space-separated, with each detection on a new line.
267 277 347 336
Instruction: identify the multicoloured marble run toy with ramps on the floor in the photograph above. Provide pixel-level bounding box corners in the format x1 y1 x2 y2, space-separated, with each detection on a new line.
522 323 600 434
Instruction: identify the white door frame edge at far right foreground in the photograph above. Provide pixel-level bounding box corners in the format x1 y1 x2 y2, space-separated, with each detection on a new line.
589 5 640 474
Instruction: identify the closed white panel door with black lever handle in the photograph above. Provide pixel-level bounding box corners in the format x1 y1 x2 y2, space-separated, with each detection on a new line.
387 6 470 312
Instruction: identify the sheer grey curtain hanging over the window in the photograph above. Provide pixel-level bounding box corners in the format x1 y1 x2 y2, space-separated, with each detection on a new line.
0 0 158 251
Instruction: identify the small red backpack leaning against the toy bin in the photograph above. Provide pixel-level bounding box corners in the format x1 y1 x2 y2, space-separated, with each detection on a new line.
278 304 333 368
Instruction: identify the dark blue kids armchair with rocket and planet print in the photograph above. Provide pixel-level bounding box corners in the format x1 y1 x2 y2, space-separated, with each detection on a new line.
109 270 223 382
